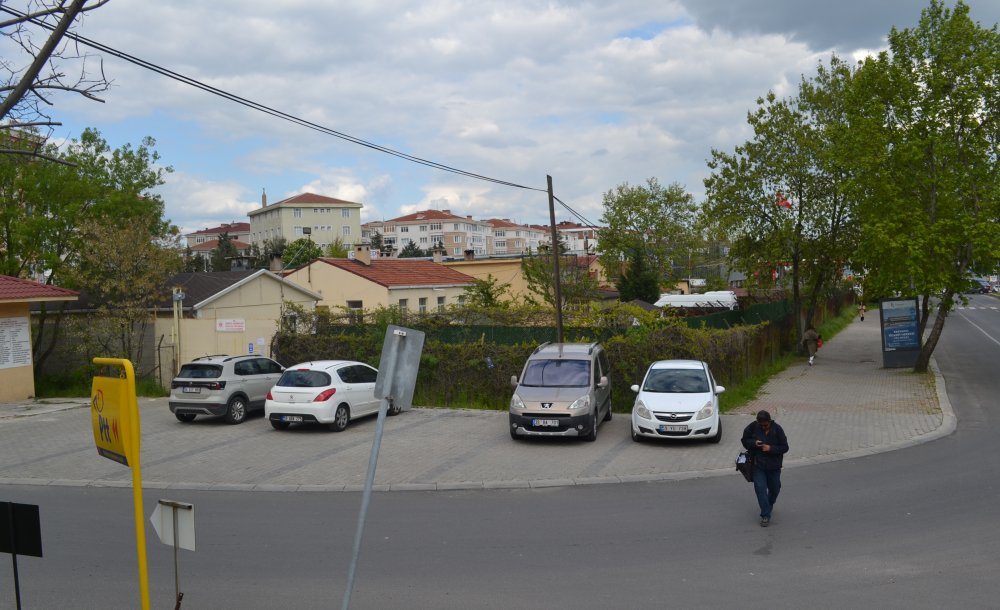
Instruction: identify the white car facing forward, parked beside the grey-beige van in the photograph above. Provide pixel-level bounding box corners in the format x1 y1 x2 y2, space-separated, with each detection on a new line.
630 360 726 443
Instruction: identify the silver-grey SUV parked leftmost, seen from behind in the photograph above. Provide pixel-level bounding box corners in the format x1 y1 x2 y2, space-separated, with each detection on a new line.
170 355 285 424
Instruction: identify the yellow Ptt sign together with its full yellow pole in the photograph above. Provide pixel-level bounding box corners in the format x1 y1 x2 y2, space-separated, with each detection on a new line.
90 358 149 610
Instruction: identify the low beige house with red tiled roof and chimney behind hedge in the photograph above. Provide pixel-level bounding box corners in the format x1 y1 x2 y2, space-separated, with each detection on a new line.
285 244 472 312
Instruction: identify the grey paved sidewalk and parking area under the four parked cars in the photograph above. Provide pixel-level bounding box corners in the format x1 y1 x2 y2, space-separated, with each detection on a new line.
0 319 955 491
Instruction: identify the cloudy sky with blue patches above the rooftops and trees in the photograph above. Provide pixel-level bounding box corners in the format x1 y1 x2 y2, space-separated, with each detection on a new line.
19 0 1000 233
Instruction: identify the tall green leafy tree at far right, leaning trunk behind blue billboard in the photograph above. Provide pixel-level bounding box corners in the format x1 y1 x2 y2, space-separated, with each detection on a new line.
848 0 1000 371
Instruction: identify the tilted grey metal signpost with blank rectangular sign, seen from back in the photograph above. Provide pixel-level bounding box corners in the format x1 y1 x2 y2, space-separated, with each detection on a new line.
343 324 424 610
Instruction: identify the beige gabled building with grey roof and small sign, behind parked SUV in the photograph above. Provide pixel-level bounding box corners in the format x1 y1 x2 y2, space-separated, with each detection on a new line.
153 269 321 387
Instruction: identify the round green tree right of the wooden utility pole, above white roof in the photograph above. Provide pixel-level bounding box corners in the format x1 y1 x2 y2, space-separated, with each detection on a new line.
599 178 698 277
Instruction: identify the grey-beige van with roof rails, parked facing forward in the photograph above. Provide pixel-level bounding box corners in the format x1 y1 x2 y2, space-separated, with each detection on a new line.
510 343 611 441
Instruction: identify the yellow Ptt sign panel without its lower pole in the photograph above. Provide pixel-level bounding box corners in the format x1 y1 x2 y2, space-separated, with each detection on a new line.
90 358 139 466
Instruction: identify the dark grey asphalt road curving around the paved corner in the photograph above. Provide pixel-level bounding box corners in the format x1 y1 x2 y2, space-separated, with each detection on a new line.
0 297 1000 609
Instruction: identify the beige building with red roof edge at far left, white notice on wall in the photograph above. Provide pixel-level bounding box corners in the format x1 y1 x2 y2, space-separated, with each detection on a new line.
0 275 77 400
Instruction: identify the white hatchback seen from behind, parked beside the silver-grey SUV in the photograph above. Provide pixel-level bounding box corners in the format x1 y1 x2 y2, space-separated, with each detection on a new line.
264 360 402 432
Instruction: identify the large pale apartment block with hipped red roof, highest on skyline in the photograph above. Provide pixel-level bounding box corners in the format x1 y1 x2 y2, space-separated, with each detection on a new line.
248 193 363 249
